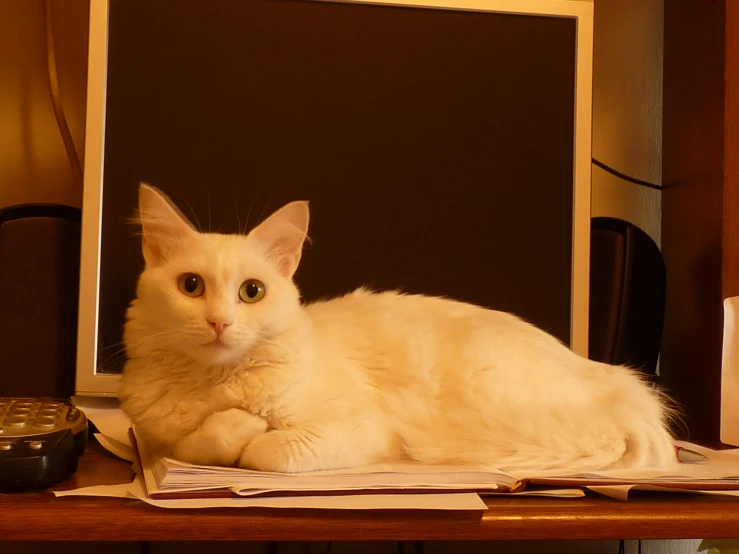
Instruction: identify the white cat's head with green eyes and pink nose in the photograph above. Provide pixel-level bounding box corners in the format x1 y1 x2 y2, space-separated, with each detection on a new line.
125 184 308 365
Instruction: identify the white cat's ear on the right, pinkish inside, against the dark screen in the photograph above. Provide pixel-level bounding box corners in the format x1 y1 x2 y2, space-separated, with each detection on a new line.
250 201 309 279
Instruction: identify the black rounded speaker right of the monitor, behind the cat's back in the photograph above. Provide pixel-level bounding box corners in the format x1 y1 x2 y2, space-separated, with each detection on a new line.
589 217 667 375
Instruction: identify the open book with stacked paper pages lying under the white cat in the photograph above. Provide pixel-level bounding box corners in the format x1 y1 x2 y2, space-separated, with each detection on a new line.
136 422 739 499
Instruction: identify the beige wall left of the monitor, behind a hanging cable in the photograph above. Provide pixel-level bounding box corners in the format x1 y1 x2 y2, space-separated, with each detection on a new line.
0 0 88 207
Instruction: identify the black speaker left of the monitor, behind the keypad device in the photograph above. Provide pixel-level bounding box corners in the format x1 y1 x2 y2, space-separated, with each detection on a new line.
0 204 81 397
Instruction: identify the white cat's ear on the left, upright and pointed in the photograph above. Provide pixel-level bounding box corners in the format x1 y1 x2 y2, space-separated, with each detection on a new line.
139 183 197 266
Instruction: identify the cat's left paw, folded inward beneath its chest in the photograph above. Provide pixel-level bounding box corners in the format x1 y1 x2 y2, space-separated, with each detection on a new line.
174 408 267 466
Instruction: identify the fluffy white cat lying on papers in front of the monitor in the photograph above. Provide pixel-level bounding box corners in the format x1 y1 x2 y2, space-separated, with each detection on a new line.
119 185 675 472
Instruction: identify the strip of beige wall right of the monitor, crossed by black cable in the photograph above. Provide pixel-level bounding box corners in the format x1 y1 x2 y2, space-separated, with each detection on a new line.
592 0 663 244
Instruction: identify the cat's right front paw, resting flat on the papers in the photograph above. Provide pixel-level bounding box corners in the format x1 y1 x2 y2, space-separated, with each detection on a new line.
239 430 316 473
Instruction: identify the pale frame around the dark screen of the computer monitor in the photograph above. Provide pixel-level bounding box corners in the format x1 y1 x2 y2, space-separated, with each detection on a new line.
75 0 593 396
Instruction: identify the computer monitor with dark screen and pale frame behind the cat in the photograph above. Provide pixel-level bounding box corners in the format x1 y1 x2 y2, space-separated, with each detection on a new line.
76 0 593 396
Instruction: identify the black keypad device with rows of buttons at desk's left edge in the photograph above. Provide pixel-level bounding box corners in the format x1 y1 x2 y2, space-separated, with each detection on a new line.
0 397 87 492
